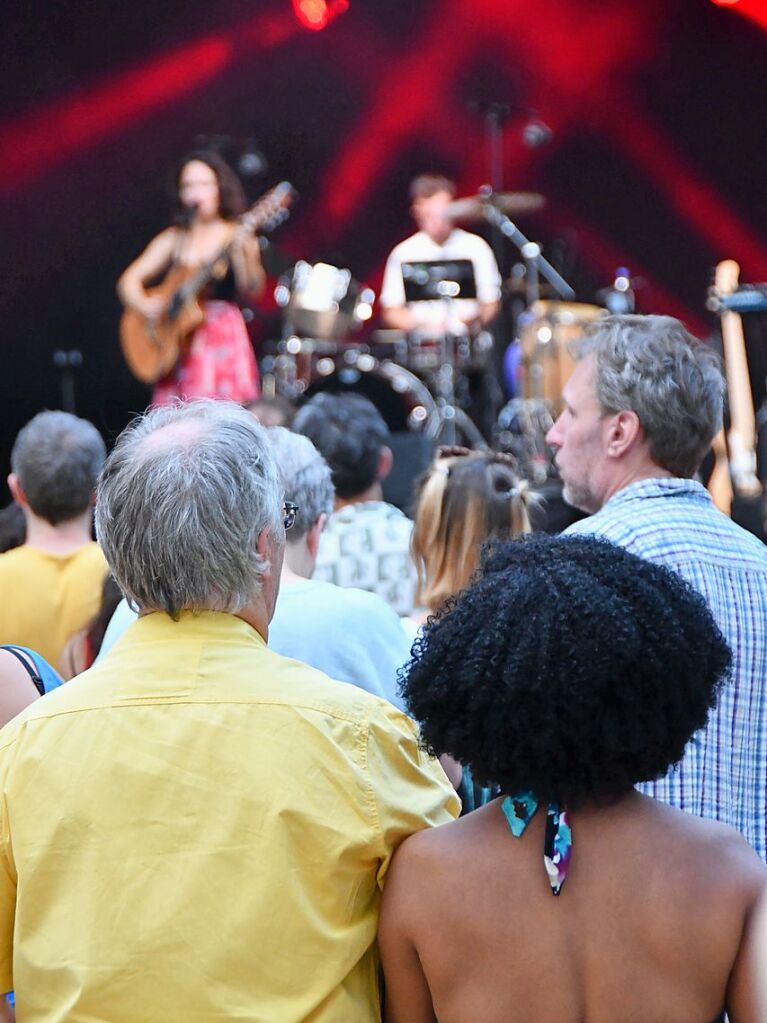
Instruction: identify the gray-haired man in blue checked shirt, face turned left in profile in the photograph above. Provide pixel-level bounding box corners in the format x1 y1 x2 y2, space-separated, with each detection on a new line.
547 316 767 858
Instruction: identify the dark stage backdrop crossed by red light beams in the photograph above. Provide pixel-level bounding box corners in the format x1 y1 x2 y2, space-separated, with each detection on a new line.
0 0 767 495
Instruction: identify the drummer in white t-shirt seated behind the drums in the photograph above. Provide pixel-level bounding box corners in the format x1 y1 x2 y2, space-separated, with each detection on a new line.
380 174 501 337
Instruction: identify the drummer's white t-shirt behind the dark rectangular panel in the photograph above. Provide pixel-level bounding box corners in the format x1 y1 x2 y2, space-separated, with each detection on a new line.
380 227 501 333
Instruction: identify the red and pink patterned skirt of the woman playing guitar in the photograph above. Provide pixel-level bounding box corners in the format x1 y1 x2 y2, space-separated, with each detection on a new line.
152 301 261 405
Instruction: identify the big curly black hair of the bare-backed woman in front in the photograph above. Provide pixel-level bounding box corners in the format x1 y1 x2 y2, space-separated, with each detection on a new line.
401 536 731 807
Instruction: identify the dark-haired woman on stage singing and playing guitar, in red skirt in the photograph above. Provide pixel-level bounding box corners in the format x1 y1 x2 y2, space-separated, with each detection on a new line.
118 152 265 405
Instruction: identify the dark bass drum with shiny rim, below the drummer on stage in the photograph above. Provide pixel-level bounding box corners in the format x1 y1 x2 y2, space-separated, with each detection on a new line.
306 351 439 437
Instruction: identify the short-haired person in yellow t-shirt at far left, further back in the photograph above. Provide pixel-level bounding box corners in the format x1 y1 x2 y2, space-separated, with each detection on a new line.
0 411 108 664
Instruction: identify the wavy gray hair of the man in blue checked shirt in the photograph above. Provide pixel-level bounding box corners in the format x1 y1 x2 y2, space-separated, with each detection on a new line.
578 315 724 477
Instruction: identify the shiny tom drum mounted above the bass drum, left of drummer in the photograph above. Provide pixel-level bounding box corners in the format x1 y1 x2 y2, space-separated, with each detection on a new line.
274 260 375 341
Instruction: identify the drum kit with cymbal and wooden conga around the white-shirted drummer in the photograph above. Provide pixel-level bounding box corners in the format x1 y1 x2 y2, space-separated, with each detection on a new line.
263 191 604 460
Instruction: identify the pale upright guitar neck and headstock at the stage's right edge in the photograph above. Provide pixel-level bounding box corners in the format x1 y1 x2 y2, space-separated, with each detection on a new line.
714 259 762 498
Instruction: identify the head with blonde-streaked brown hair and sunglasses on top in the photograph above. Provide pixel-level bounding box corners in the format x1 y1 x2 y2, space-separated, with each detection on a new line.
411 451 533 609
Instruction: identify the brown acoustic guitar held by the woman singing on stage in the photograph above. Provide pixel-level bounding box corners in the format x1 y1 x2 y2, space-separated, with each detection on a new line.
120 181 296 384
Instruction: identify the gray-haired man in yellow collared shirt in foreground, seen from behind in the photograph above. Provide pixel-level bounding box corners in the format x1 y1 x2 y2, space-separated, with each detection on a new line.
0 401 458 1023
